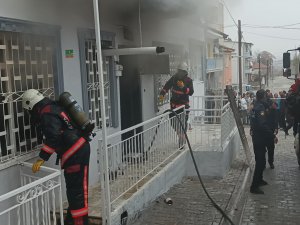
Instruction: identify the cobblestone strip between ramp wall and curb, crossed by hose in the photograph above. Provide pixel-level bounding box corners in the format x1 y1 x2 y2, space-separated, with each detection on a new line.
134 142 245 225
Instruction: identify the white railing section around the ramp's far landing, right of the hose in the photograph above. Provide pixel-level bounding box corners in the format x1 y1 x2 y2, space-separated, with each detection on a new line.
188 96 236 151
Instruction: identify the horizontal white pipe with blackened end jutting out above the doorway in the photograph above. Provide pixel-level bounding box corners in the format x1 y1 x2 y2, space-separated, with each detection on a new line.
102 47 165 56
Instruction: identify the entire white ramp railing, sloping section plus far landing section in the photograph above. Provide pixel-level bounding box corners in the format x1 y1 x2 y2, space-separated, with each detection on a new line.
98 96 235 223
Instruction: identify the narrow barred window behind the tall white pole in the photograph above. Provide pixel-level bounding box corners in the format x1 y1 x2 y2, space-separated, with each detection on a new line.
85 39 112 128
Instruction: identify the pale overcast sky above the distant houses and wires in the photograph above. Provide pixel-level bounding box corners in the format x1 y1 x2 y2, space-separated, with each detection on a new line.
224 0 300 59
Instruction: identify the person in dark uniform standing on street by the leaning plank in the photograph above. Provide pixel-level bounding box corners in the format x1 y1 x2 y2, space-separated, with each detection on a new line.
250 89 278 194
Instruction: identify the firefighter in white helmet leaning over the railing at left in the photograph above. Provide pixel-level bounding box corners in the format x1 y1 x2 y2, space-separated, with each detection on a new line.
22 89 90 225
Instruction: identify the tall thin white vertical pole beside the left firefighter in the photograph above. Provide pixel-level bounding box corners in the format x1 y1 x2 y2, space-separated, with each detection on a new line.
93 0 111 225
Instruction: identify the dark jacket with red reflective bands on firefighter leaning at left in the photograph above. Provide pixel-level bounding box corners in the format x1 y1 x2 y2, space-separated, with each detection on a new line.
35 99 86 168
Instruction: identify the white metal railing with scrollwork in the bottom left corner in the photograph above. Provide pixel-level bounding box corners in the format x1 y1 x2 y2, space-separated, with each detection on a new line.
0 163 64 225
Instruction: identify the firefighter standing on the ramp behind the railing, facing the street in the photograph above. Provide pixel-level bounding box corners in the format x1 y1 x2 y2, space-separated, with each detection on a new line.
160 63 194 147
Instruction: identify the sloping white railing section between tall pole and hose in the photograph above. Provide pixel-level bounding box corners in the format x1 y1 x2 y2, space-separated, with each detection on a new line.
100 107 185 208
